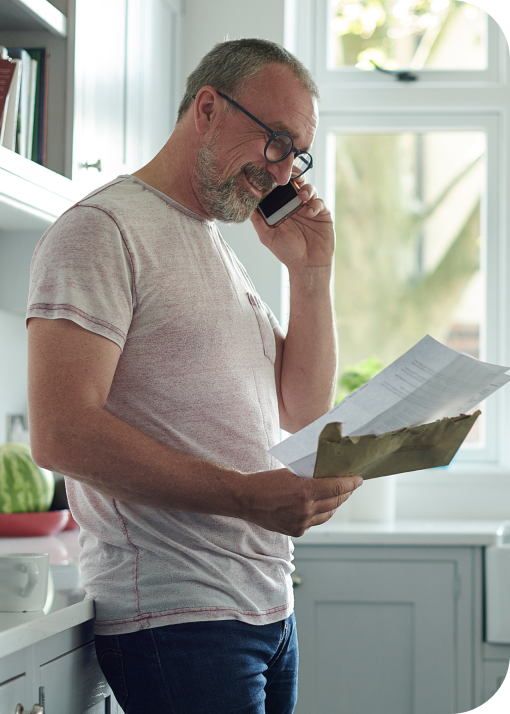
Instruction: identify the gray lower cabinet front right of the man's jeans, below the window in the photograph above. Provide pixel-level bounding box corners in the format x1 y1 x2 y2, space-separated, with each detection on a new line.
296 559 457 714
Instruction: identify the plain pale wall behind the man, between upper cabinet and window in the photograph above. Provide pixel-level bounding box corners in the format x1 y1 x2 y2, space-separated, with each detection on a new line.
181 0 285 319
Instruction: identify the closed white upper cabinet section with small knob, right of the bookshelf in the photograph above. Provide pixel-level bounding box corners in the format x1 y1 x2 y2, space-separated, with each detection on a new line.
72 0 180 192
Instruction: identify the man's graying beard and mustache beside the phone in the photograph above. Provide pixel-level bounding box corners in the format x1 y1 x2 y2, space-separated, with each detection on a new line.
194 132 277 223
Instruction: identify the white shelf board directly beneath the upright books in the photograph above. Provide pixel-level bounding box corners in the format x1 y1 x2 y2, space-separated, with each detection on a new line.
0 147 81 231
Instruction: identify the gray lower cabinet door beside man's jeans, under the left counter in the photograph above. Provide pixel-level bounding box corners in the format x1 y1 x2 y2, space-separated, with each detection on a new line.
40 642 110 714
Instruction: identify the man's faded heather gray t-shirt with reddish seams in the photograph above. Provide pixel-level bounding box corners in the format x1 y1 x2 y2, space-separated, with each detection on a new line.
27 176 293 634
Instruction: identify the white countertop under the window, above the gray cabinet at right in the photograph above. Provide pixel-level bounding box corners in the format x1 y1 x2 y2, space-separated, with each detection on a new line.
293 520 504 546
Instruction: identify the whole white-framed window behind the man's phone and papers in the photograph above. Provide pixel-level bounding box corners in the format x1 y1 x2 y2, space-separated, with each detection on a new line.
287 0 510 517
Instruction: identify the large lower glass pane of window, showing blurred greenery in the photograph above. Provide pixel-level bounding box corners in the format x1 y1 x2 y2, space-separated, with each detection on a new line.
335 132 485 441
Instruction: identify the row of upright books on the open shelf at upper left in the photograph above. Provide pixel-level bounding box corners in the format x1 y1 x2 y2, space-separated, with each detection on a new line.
0 47 49 166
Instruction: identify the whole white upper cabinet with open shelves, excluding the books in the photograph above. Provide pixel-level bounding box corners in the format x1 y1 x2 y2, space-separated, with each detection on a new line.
0 0 180 231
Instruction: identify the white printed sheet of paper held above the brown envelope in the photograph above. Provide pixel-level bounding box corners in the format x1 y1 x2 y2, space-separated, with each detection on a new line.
269 335 510 478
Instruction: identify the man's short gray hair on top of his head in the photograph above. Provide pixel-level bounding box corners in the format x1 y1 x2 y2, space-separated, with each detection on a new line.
177 38 320 121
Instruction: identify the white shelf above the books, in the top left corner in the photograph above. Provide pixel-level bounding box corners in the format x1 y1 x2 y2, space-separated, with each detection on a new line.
0 0 67 37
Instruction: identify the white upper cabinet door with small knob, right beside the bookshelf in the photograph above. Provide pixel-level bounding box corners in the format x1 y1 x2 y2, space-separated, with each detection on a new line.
73 0 128 192
